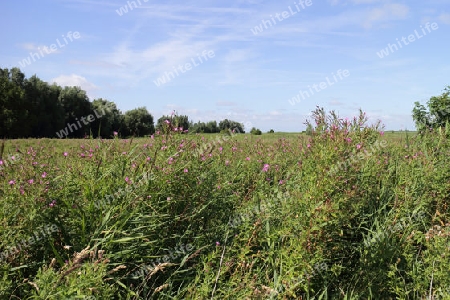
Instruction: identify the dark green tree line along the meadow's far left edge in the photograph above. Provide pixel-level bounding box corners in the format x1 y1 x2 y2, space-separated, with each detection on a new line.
0 68 245 138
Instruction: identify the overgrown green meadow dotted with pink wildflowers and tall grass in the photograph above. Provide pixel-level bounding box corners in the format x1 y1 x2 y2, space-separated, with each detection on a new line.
0 111 450 299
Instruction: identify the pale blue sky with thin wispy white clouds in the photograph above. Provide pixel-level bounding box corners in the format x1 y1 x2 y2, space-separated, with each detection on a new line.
0 0 450 132
